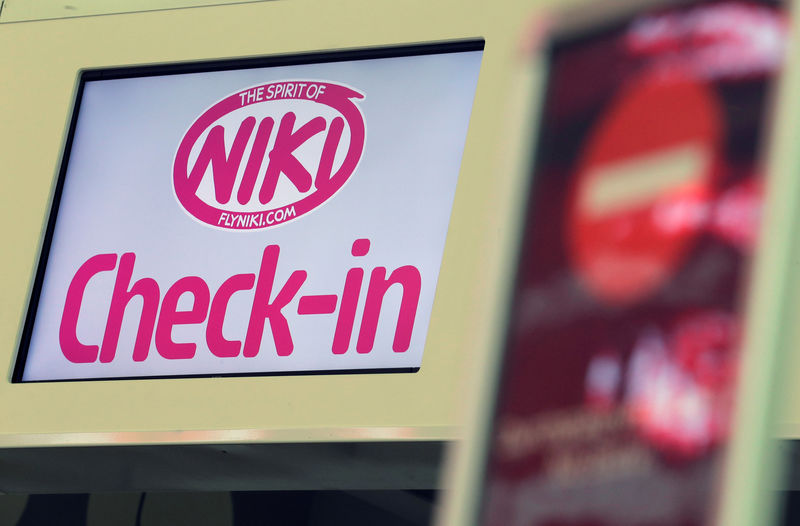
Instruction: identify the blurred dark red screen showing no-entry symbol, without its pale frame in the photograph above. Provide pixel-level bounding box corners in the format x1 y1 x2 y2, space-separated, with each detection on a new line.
477 1 786 526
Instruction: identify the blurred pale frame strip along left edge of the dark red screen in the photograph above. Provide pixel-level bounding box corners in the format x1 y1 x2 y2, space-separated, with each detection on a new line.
434 9 550 526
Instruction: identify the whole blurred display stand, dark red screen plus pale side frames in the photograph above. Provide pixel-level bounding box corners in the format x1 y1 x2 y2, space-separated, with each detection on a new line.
439 1 800 526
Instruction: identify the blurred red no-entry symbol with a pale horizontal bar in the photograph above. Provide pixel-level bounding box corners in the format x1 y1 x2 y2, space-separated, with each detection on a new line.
567 72 722 304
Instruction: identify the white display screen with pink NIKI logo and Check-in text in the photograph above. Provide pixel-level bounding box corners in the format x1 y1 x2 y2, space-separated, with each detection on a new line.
14 43 482 381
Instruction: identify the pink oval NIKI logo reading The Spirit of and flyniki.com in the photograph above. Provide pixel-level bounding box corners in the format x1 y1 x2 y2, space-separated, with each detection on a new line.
173 81 366 230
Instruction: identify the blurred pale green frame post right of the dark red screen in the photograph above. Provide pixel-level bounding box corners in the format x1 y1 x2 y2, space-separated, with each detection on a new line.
718 0 800 526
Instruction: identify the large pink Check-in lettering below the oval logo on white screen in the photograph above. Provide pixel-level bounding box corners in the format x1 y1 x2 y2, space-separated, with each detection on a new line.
59 238 422 363
